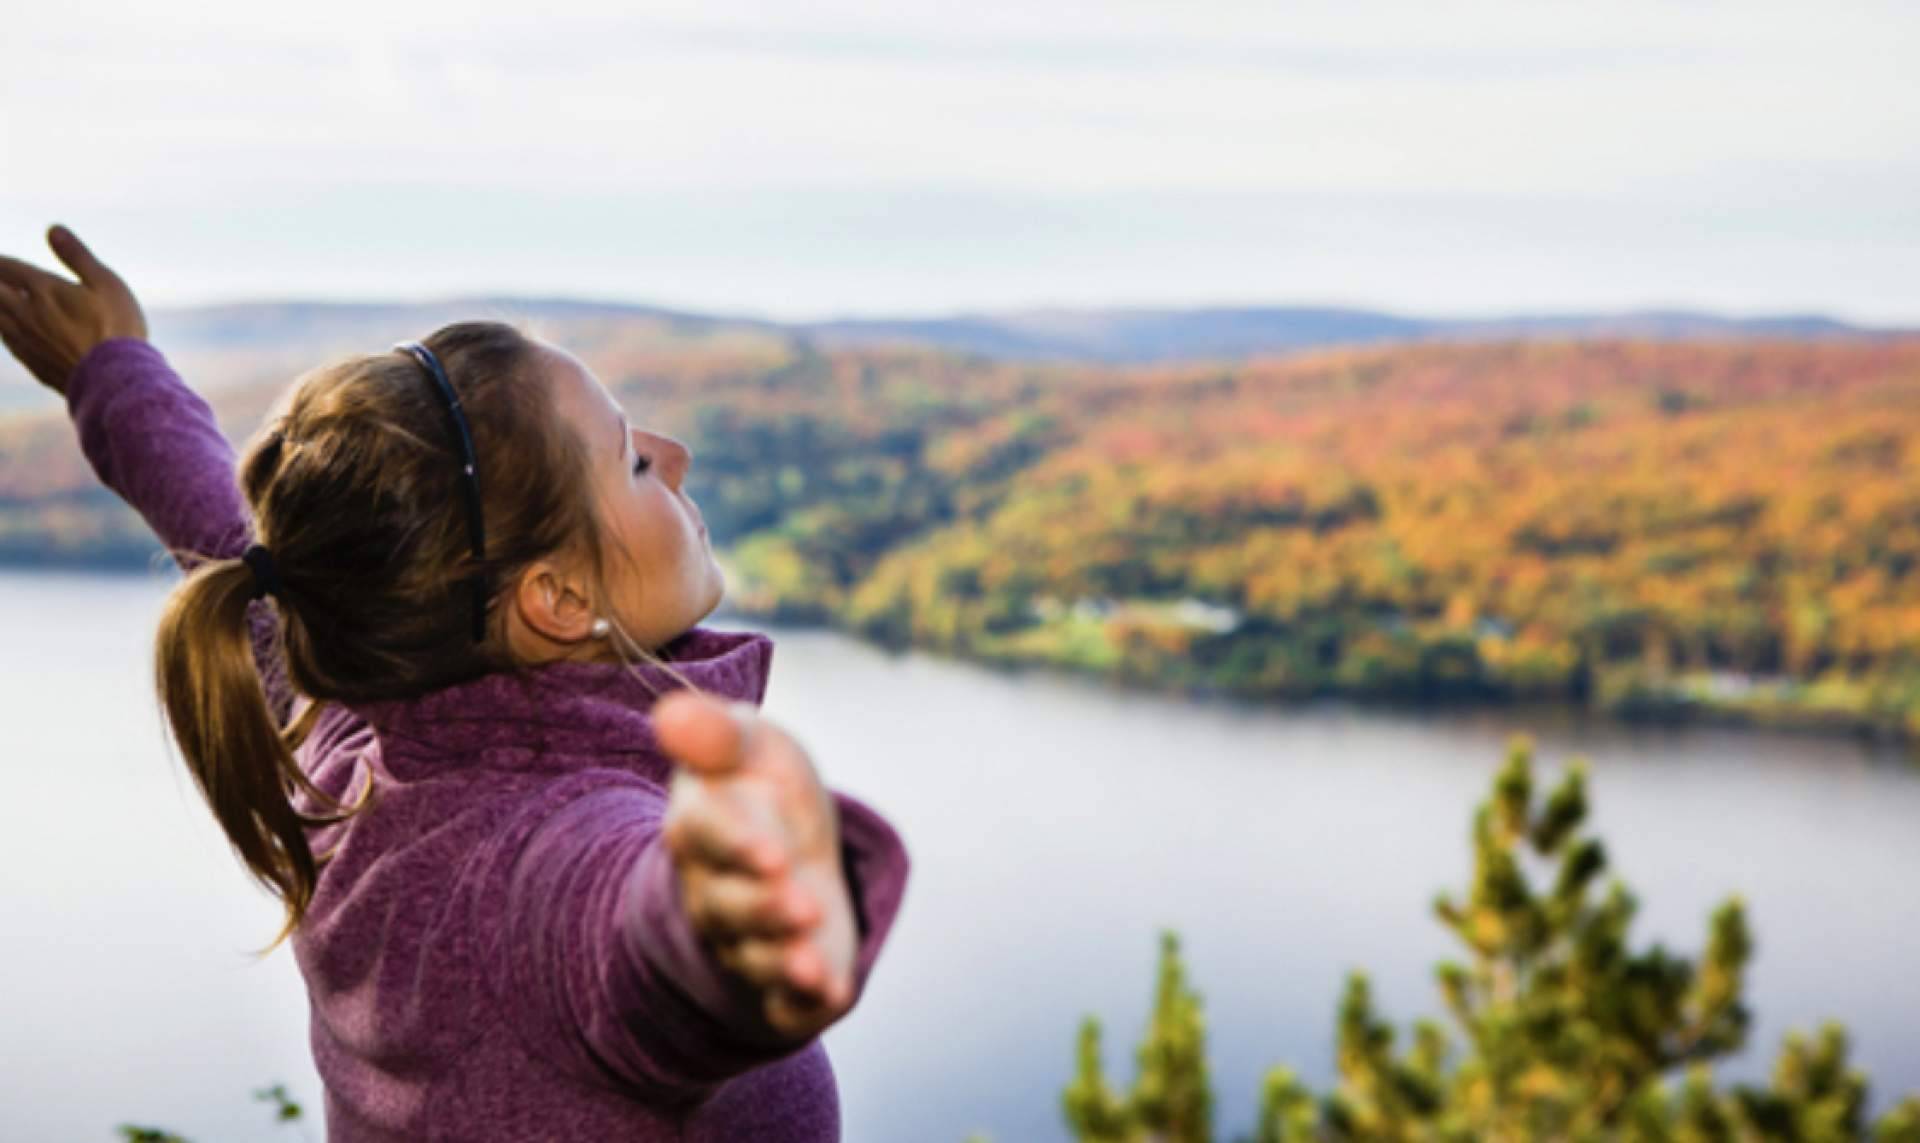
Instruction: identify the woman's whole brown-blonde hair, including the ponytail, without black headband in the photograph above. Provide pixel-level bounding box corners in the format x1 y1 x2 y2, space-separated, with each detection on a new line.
154 321 714 947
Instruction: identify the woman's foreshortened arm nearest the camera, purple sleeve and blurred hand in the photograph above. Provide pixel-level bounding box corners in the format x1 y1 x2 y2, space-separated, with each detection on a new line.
499 692 906 1103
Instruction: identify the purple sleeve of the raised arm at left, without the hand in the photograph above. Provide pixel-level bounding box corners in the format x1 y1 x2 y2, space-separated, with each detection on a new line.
67 338 294 722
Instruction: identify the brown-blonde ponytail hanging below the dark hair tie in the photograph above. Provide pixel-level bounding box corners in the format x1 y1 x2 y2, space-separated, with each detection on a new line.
154 559 357 949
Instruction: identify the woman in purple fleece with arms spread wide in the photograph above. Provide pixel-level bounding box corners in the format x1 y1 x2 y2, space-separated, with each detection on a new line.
0 227 906 1141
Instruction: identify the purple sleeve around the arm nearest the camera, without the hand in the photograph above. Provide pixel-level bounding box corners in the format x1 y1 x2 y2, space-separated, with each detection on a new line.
503 788 906 1105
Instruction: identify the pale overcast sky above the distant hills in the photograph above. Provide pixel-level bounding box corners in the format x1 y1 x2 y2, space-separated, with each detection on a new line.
0 0 1920 325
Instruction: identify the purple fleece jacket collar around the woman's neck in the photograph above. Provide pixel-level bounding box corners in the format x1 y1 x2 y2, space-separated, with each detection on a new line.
351 626 774 780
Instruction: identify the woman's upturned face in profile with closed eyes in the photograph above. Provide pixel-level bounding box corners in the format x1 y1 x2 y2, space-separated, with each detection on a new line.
538 344 726 657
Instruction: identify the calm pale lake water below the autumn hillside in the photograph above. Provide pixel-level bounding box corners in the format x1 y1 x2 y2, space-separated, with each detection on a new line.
0 572 1920 1143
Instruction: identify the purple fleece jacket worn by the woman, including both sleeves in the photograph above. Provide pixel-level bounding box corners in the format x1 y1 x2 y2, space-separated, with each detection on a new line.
67 338 906 1143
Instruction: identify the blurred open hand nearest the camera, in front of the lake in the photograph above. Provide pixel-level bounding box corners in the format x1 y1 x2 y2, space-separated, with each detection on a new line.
653 692 858 1039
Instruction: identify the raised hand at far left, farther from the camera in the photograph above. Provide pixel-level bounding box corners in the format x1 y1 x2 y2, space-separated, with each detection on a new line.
0 227 146 394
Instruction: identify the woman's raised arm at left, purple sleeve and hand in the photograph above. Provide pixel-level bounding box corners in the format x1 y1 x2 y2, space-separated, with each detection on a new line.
0 227 294 722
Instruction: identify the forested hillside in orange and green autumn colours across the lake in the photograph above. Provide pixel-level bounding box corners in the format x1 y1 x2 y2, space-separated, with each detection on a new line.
0 319 1920 734
